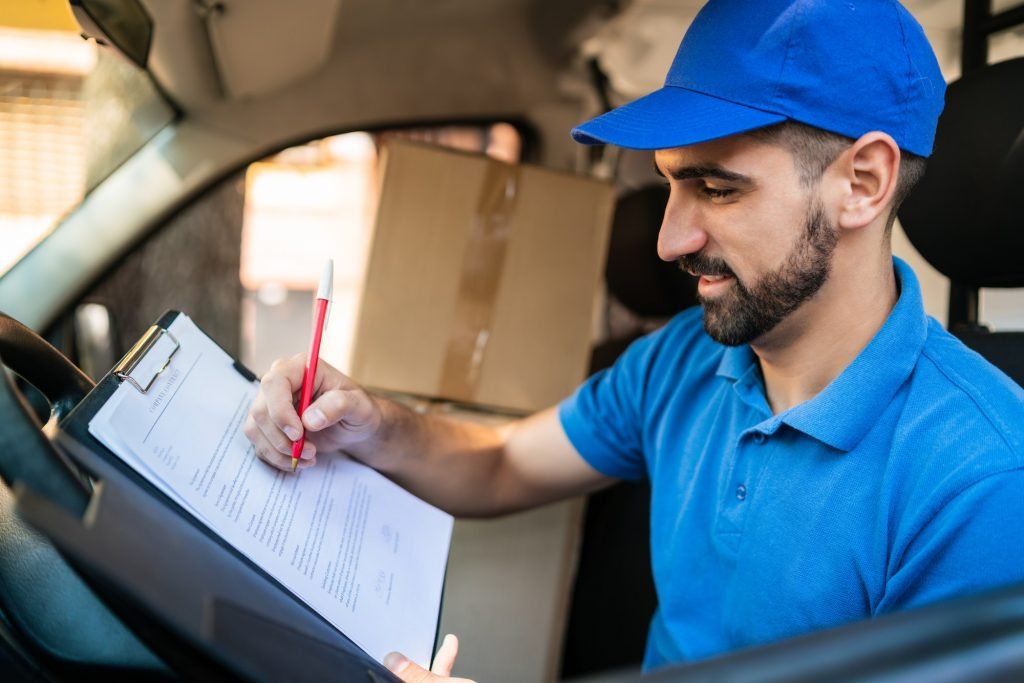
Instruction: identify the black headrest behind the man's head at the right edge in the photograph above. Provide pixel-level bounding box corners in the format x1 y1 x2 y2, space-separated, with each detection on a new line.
899 57 1024 287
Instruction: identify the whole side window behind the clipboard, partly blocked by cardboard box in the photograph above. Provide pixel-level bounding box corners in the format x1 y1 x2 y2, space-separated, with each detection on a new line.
74 123 522 375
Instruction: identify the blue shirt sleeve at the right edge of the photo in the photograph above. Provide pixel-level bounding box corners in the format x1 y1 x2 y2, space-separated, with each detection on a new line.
877 469 1024 613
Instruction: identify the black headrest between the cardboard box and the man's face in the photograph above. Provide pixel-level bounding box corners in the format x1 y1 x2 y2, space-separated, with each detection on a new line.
605 185 696 317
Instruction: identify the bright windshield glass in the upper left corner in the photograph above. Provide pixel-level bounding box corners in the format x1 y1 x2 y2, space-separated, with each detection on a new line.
0 28 174 275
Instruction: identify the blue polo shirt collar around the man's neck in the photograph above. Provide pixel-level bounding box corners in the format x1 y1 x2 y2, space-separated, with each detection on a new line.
717 257 928 452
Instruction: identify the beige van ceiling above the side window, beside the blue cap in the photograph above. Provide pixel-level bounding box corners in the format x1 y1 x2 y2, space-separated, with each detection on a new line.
128 0 983 152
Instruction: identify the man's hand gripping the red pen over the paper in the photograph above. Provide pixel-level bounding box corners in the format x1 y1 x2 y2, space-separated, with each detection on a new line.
245 353 382 472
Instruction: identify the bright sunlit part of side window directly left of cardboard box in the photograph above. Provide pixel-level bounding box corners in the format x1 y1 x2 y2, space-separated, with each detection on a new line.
241 133 377 376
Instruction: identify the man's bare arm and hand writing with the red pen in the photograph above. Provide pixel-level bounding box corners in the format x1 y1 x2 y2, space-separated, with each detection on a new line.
245 354 612 516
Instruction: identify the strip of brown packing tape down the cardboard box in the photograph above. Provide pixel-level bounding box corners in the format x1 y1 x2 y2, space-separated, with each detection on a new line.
440 160 519 399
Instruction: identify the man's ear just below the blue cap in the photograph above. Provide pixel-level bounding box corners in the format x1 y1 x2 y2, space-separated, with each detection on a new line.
830 131 900 229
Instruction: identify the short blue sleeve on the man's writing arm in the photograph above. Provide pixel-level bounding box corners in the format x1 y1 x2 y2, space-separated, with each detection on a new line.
558 333 660 480
